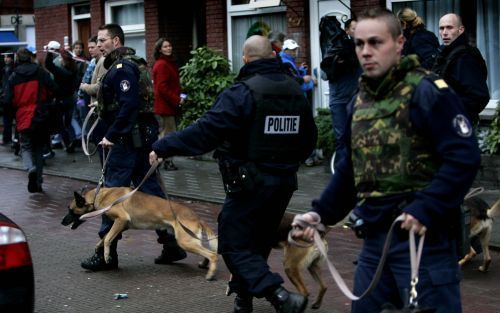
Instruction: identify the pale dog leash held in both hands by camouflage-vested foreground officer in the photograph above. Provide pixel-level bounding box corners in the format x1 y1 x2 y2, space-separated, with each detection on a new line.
288 214 412 301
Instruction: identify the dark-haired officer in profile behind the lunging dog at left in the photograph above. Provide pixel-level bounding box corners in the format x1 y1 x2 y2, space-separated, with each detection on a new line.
81 24 186 271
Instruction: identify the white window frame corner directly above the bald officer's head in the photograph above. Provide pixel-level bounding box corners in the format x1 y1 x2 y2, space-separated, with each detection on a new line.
226 0 286 70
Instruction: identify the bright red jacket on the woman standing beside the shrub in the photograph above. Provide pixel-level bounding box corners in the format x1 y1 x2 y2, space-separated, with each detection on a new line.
153 55 181 116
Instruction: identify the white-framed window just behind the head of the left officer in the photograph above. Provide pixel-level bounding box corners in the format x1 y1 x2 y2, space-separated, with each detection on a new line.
106 0 146 58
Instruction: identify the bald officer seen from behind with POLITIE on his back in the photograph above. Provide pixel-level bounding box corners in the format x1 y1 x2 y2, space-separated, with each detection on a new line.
150 35 317 313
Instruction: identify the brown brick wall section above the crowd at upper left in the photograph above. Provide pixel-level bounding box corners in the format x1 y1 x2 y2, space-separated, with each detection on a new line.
35 4 73 58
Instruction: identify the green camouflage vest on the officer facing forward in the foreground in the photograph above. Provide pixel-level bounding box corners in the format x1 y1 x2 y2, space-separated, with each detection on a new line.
351 56 437 199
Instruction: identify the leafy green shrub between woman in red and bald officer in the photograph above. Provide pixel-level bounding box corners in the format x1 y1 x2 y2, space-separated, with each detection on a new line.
179 47 235 129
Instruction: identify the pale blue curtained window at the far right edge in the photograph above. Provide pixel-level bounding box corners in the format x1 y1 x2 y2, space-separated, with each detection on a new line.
477 0 500 100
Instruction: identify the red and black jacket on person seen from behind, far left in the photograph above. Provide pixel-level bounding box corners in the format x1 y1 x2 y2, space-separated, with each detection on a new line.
6 63 56 131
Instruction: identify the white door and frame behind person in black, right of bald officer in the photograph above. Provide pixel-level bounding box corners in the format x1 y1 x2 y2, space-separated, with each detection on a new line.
310 0 351 108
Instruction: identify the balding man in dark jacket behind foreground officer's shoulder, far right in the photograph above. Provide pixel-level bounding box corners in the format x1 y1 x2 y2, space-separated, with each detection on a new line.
432 13 490 125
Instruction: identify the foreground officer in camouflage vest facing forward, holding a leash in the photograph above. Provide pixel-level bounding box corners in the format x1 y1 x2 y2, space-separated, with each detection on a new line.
295 8 480 313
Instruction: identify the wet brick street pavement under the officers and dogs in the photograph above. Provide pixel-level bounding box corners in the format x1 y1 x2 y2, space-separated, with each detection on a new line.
0 143 500 313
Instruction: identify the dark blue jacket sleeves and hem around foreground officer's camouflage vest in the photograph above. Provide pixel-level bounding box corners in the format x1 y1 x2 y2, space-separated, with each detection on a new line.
311 73 480 233
